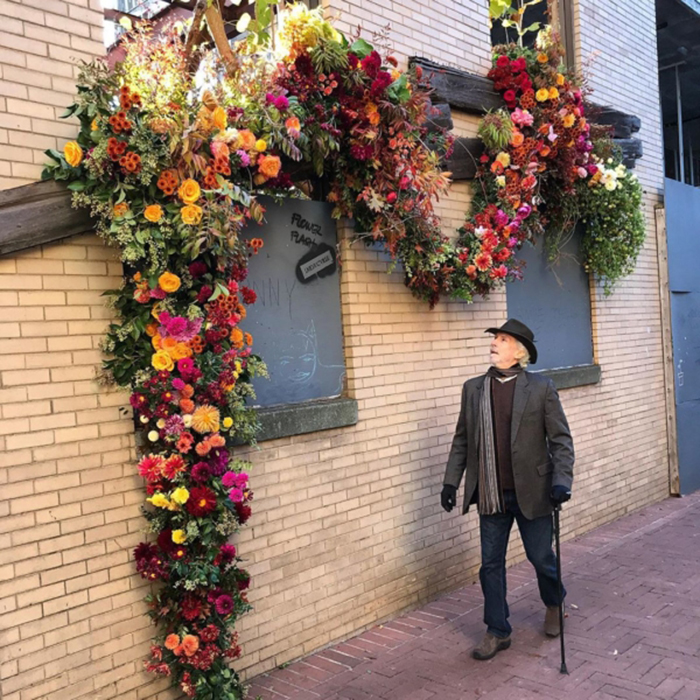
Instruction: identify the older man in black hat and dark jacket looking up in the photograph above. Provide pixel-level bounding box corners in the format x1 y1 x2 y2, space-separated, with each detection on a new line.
441 319 574 660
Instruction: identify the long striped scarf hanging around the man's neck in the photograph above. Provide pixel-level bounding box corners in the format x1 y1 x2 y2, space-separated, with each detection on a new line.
478 365 522 515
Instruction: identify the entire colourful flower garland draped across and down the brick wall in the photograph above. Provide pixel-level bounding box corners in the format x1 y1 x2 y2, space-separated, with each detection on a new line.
44 5 643 700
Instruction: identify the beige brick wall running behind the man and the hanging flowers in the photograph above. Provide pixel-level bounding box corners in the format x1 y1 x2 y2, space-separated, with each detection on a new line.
0 0 668 700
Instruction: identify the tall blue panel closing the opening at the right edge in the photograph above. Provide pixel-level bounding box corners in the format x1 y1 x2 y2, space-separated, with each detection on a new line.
665 179 700 494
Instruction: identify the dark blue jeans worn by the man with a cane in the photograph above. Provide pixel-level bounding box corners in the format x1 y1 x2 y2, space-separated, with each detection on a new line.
479 491 566 637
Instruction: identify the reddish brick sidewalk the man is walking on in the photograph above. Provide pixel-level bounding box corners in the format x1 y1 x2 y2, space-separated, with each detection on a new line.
249 494 700 700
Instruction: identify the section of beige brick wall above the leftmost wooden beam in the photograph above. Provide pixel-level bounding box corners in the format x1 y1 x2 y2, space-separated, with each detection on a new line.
0 0 104 189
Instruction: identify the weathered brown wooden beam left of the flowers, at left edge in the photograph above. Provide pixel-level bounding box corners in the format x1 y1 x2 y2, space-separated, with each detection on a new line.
0 180 94 255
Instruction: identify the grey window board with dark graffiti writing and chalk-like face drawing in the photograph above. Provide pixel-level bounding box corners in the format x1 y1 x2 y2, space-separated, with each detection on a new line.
241 199 345 406
